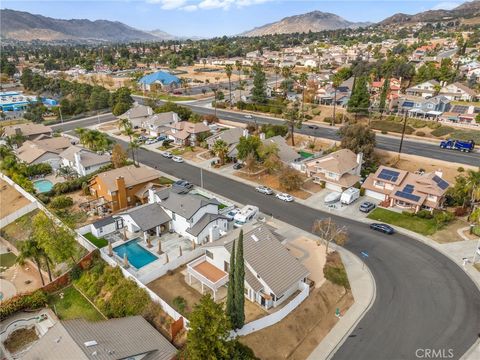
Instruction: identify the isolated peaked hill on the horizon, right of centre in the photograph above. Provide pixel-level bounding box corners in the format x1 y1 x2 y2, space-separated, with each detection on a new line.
240 11 371 36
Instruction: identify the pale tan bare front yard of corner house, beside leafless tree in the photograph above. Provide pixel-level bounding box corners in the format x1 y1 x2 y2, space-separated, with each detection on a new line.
286 236 326 288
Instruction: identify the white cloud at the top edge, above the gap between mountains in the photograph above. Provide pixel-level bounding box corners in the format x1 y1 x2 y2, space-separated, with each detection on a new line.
147 0 273 11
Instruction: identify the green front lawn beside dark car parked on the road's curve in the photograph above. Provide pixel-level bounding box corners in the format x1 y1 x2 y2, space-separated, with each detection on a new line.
368 208 437 235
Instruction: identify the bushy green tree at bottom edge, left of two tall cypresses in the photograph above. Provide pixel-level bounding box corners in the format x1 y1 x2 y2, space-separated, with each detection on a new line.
186 294 233 360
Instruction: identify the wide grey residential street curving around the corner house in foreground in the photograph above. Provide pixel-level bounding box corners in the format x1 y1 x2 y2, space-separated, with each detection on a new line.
116 142 480 360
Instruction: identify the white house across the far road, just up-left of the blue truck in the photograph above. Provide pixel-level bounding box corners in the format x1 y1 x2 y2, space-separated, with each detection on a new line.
398 95 451 119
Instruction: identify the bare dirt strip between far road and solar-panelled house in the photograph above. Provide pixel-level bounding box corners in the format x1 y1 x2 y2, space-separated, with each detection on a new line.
376 150 475 183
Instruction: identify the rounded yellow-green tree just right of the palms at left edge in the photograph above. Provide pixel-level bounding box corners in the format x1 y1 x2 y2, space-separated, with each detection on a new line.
32 212 77 263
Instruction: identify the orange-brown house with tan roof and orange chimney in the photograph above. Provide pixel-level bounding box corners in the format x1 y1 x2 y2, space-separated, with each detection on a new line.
89 165 161 211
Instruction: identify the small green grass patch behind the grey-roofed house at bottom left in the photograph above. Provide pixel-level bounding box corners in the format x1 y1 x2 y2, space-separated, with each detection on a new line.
50 286 104 321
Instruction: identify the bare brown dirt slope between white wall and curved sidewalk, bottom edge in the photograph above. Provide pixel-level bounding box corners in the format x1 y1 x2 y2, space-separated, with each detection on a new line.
240 281 353 360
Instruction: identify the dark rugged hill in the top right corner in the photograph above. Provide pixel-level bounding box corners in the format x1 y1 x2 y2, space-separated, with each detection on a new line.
379 0 480 25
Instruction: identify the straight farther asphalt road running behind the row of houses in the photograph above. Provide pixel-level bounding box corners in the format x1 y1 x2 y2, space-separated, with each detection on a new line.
52 101 480 166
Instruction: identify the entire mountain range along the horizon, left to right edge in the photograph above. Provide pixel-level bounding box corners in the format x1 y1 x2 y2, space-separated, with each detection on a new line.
0 0 480 42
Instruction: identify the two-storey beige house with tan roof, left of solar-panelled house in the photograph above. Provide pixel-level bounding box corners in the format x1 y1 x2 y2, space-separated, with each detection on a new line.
303 149 363 192
